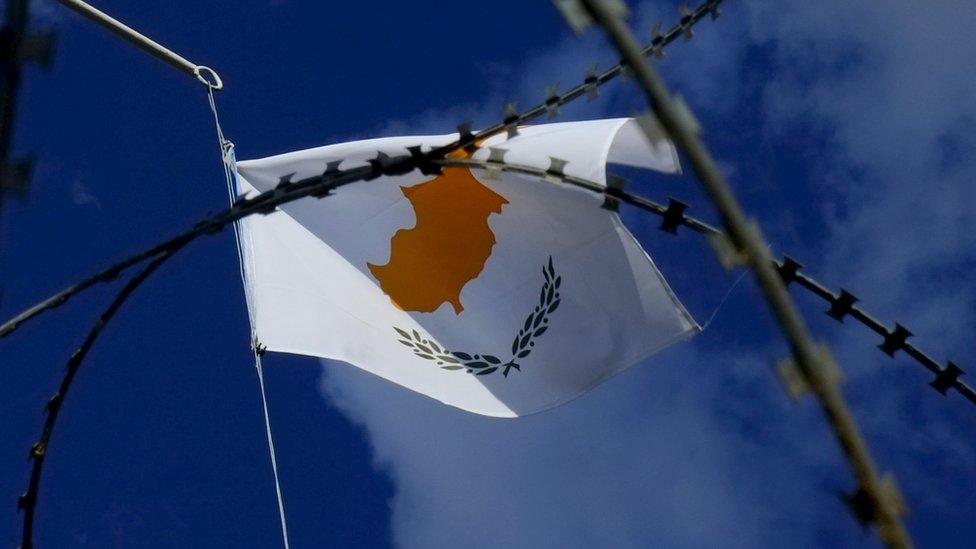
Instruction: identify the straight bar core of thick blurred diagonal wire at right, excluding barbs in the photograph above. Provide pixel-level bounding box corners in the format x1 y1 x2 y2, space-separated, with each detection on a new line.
581 0 911 547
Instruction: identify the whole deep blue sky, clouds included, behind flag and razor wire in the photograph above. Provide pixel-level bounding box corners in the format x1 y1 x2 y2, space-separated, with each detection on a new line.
0 0 976 547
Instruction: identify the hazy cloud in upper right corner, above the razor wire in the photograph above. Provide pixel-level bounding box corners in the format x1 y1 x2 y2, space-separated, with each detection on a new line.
753 0 976 296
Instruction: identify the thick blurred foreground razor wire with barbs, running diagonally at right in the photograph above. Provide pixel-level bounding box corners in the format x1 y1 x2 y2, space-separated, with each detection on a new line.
576 0 911 548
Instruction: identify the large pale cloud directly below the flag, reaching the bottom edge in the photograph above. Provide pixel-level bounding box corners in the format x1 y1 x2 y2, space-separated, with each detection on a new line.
323 349 860 547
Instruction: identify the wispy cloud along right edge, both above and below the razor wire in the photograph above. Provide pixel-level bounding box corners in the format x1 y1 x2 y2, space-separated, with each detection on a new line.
740 1 976 514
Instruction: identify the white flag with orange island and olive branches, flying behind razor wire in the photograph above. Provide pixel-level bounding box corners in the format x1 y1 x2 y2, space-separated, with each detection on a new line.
237 119 700 417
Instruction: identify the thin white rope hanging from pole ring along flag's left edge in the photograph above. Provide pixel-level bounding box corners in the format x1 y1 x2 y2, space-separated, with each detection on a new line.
207 86 289 549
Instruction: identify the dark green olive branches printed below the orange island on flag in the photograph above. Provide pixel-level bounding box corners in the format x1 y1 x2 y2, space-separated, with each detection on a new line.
393 256 562 377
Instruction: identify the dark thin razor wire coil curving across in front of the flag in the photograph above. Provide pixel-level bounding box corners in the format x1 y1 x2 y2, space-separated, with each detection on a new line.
11 0 960 547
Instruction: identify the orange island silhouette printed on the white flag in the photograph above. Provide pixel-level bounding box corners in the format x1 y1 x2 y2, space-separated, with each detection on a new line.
367 153 508 314
